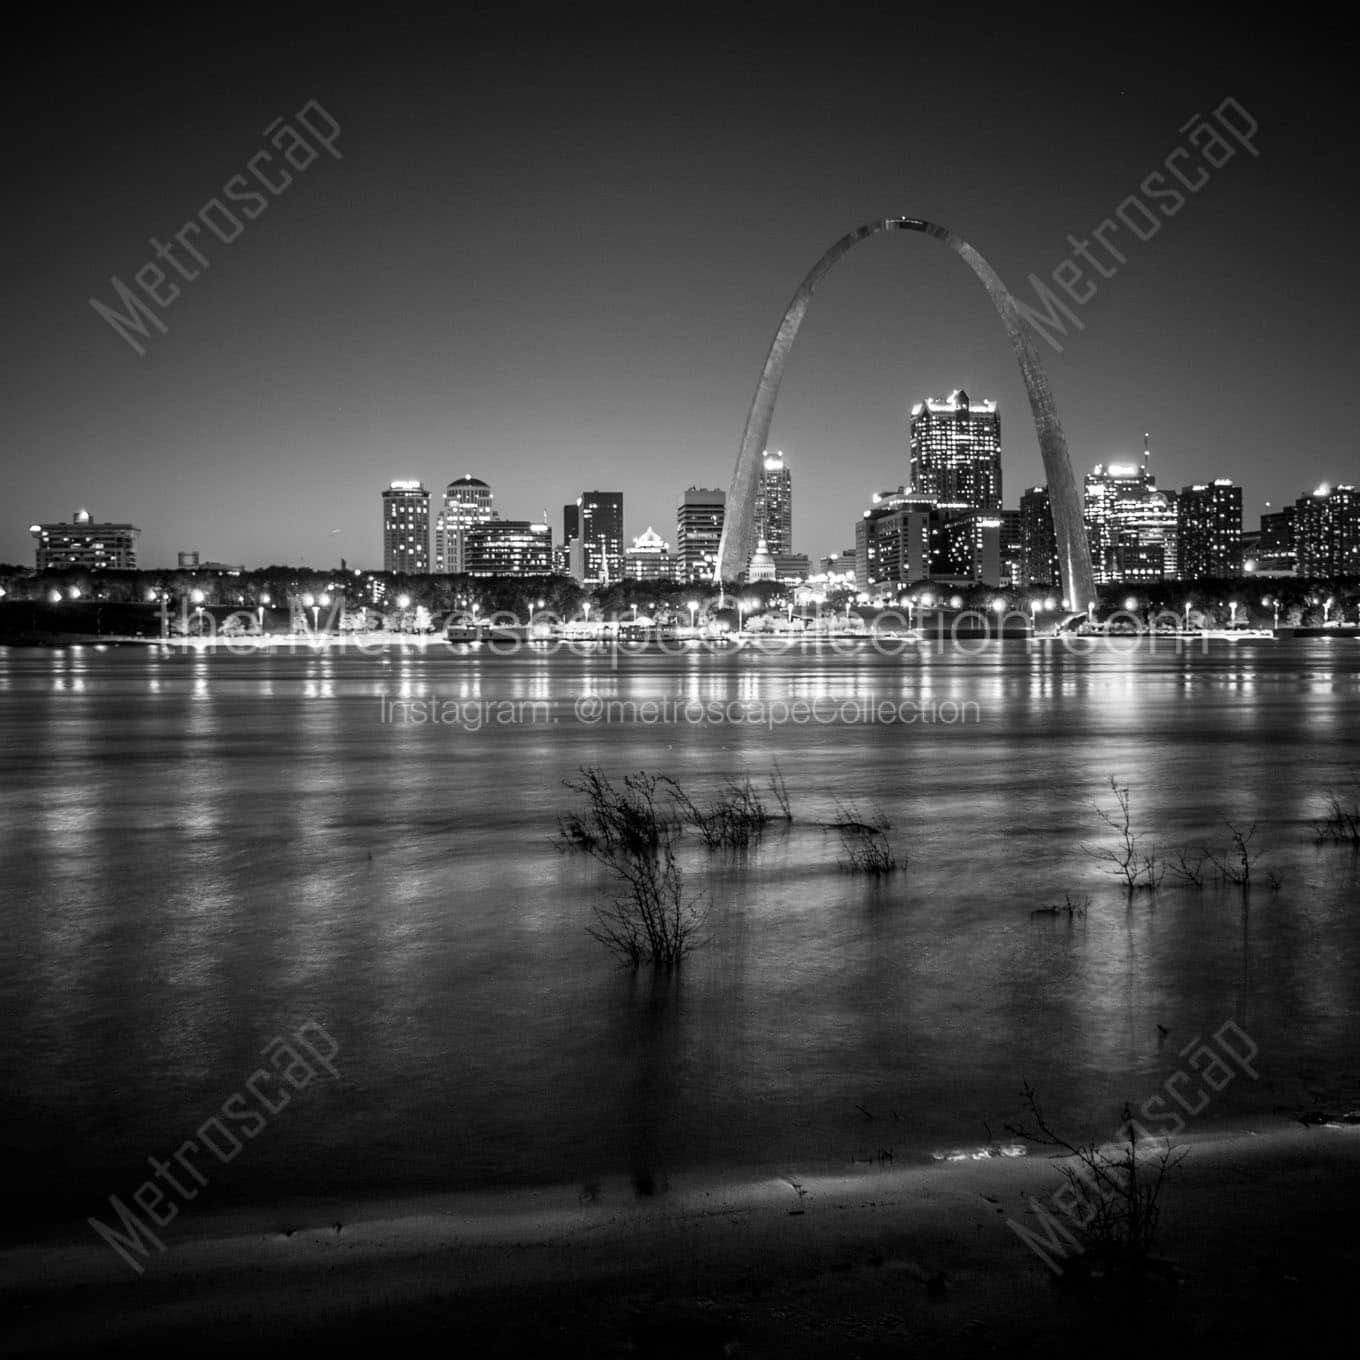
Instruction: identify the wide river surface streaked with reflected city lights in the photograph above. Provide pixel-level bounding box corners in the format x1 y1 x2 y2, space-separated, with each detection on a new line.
0 641 1360 1234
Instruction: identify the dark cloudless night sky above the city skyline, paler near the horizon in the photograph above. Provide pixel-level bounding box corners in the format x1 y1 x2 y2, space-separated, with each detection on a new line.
0 7 1360 567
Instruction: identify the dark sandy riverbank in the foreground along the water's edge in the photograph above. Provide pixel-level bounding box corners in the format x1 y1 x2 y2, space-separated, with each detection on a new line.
0 1127 1360 1357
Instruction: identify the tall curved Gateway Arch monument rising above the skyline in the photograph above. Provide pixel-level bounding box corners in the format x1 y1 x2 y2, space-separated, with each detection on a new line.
715 218 1096 609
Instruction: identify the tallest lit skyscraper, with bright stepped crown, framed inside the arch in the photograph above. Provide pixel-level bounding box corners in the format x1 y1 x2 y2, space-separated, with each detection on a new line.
910 390 1001 511
